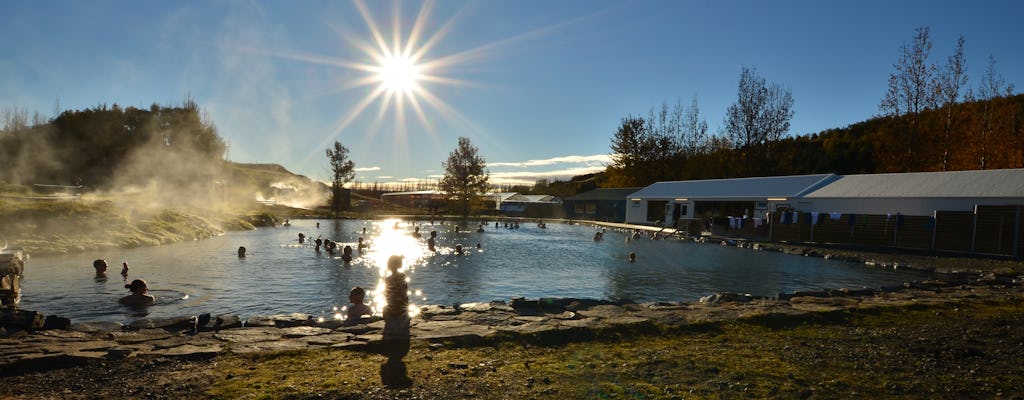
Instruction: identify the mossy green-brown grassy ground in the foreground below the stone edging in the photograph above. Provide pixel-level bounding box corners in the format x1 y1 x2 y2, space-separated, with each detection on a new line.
207 299 1024 399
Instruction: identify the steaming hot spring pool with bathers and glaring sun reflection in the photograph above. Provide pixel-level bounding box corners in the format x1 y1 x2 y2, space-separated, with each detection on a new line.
20 219 931 322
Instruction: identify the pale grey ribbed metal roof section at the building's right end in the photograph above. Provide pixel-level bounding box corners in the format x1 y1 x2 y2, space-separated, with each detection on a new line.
805 169 1024 198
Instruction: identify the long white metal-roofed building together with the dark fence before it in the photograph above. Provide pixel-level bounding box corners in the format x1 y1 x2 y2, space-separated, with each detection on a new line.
626 169 1024 257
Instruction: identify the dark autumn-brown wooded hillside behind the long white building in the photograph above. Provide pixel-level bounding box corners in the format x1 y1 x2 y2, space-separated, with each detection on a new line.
601 95 1024 187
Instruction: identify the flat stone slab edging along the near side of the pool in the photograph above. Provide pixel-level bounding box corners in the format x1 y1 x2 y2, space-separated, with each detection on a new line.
0 275 1024 375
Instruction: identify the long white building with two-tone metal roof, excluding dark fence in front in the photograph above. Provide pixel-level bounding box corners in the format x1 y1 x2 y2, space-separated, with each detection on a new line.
626 169 1024 224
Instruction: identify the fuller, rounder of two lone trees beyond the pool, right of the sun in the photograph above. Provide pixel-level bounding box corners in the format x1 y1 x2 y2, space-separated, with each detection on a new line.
437 137 490 216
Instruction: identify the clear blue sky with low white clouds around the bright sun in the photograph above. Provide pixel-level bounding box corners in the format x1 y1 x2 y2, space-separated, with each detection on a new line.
0 0 1024 186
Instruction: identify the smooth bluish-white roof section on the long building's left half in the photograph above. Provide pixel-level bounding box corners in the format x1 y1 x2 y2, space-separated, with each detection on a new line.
629 174 836 199
